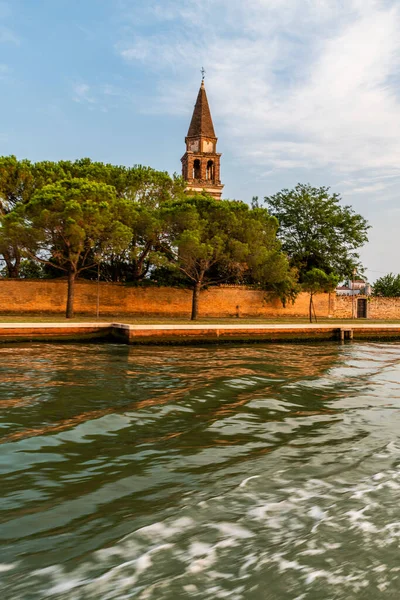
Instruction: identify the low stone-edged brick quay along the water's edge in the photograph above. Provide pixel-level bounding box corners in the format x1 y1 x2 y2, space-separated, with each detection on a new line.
0 321 400 344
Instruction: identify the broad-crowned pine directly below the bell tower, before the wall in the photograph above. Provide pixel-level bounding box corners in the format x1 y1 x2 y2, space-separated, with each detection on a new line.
163 196 289 320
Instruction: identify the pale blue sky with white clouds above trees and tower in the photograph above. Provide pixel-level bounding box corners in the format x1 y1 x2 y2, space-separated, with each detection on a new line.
0 0 400 282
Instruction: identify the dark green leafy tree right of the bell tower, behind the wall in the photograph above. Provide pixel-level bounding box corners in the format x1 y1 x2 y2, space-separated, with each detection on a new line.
264 184 369 281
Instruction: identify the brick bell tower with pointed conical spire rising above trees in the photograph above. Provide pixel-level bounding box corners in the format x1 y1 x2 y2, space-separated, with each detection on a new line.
181 75 224 200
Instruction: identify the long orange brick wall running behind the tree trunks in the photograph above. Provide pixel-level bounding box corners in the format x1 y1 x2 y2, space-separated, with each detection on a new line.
0 279 334 317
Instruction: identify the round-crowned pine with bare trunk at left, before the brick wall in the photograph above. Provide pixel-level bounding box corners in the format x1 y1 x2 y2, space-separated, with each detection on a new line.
5 179 132 318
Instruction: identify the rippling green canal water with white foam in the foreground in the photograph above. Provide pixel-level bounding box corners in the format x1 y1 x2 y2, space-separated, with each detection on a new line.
0 343 400 600
